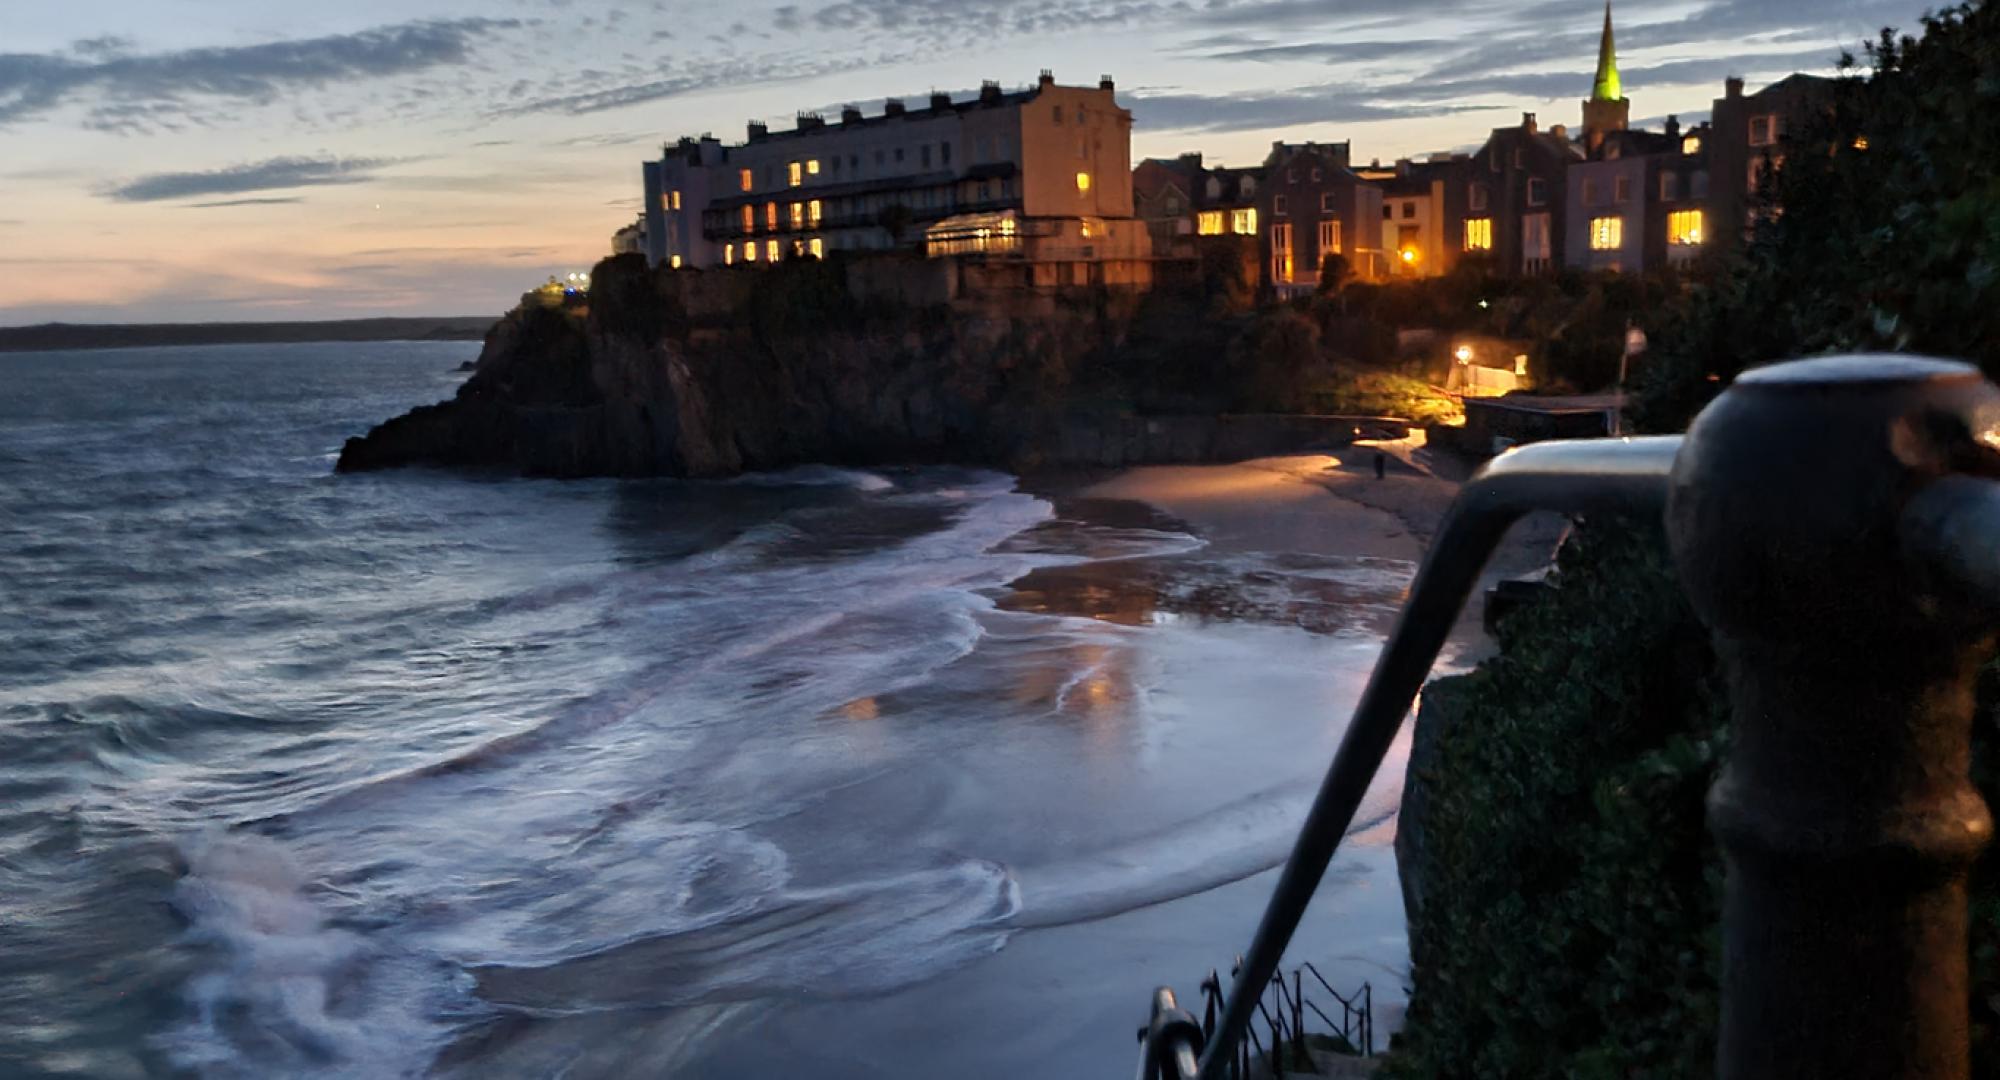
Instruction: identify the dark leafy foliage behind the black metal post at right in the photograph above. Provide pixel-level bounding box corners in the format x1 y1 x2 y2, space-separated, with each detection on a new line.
1394 4 2000 1078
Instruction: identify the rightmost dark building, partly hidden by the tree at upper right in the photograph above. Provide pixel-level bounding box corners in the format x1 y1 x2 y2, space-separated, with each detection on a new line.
1708 74 1834 255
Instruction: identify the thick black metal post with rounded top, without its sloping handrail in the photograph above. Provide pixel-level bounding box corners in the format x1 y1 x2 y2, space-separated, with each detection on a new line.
1666 356 2000 1080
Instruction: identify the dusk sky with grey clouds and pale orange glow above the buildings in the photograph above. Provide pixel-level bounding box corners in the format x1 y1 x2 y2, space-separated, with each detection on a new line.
0 0 1926 326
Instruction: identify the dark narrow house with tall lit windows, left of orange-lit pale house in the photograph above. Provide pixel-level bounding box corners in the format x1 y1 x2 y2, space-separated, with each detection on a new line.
1252 142 1388 296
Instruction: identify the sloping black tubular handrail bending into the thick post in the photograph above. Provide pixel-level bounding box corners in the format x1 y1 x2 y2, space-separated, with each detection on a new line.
1200 436 1680 1080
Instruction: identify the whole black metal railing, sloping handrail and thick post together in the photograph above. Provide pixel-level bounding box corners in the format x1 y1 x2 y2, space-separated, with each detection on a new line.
1148 356 2000 1080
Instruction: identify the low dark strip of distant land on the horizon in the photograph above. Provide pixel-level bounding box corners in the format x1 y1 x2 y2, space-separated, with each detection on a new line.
0 316 494 352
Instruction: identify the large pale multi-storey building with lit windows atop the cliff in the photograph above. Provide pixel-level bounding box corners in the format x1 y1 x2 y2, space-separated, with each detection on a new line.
644 72 1150 268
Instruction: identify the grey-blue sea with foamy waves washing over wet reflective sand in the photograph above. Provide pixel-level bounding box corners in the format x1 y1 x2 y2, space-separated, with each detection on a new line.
0 342 1412 1078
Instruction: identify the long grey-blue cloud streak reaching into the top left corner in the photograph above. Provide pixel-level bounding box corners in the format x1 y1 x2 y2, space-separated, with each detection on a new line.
0 18 520 130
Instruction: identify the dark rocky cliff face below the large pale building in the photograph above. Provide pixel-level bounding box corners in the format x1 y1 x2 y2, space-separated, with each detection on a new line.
338 256 1122 476
